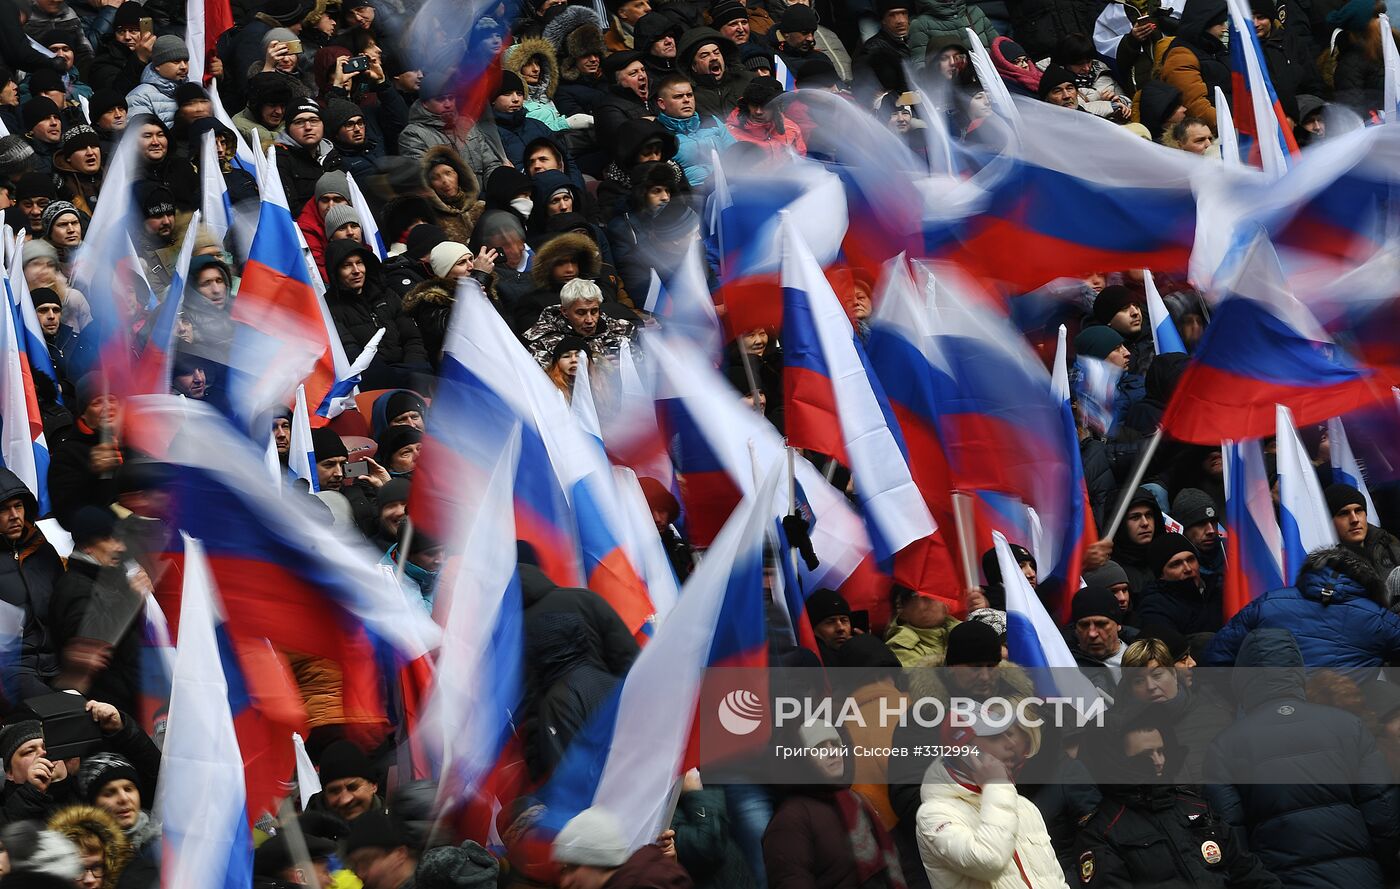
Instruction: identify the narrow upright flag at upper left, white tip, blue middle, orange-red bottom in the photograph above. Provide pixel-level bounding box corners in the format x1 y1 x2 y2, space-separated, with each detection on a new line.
232 148 354 426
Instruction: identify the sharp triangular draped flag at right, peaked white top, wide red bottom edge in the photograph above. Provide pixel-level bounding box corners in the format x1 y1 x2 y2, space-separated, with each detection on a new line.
1162 237 1379 444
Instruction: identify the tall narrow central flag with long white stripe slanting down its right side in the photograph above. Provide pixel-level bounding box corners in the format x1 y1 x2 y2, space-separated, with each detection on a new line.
783 217 937 561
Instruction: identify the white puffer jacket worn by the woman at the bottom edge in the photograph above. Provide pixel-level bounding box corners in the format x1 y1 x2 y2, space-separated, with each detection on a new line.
917 762 1068 889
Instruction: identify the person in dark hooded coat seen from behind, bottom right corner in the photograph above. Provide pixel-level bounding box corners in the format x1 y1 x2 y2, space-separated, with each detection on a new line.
1205 629 1400 889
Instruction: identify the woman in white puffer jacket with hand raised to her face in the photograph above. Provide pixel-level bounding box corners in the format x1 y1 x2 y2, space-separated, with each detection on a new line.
917 722 1067 889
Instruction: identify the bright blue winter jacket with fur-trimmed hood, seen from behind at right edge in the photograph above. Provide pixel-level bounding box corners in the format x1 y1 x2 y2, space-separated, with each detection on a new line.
1204 568 1400 671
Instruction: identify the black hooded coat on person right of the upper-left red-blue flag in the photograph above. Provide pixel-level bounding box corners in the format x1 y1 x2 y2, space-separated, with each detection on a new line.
326 241 428 385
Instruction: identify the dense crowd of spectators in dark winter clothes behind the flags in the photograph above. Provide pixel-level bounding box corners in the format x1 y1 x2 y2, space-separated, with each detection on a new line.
0 0 1400 889
